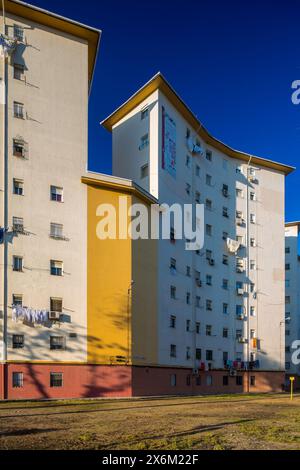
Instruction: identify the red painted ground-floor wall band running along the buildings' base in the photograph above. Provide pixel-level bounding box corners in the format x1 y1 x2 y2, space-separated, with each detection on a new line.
0 363 284 400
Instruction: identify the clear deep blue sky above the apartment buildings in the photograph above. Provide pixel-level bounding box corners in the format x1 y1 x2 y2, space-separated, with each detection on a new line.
28 0 300 220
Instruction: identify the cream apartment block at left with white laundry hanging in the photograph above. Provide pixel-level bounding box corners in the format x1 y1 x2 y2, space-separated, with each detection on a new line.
0 0 100 398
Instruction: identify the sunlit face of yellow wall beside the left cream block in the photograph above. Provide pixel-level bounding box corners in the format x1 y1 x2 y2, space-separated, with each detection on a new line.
87 185 132 364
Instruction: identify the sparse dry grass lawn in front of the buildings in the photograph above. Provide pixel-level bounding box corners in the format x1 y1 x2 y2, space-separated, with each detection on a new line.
0 394 300 450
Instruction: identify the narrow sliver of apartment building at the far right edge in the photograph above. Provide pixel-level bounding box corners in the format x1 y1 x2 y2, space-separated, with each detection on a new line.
285 222 300 388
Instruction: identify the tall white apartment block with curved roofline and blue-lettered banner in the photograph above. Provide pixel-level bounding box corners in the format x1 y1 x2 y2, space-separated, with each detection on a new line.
102 73 293 394
